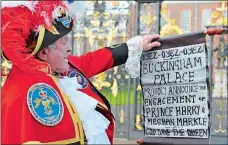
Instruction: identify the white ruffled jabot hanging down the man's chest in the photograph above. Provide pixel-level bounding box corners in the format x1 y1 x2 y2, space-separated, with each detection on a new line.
59 76 110 144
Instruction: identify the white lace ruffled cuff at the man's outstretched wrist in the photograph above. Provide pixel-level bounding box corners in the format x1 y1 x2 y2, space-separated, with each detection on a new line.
125 36 143 78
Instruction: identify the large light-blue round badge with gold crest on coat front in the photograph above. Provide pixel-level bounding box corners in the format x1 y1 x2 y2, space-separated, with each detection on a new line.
27 83 64 126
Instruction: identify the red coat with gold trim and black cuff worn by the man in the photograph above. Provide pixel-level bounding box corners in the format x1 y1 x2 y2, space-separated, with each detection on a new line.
1 44 127 144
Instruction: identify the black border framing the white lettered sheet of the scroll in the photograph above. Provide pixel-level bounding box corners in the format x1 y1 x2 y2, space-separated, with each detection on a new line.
140 31 212 144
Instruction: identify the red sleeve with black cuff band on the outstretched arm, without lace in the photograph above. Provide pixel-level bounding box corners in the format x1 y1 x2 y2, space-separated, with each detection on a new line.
68 43 128 78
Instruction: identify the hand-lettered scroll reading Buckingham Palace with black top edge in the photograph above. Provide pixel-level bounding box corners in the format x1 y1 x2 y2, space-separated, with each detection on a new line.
140 32 210 139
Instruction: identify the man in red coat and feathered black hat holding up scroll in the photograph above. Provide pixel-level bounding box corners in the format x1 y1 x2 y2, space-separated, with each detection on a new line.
1 1 160 144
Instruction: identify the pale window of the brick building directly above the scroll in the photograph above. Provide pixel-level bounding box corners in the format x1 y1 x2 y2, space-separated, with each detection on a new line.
181 10 191 33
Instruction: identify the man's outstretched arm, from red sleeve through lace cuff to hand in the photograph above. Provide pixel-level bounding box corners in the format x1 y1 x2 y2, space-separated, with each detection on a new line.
68 34 160 77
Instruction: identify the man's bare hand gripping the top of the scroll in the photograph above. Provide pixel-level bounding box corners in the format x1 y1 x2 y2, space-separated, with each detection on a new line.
142 34 161 51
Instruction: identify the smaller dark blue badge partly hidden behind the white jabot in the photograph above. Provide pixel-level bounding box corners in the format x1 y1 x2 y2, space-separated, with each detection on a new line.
67 69 89 89
